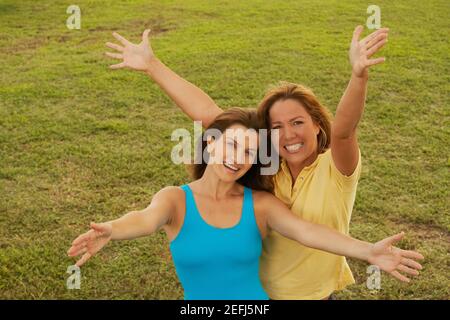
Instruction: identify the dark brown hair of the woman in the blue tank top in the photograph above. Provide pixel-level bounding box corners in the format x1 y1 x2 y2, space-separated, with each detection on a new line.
188 107 273 192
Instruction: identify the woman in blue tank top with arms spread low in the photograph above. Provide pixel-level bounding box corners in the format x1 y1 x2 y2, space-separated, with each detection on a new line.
68 108 423 300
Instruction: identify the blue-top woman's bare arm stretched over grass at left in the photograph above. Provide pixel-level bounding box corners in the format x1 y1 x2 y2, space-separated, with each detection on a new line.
67 187 176 266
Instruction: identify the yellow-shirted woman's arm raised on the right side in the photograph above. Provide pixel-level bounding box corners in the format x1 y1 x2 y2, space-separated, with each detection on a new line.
331 26 389 175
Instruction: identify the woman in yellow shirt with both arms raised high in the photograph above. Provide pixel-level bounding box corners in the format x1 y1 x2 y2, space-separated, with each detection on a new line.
106 26 394 299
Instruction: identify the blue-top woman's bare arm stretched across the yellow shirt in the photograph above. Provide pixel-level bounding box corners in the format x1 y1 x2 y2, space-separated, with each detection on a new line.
255 193 423 282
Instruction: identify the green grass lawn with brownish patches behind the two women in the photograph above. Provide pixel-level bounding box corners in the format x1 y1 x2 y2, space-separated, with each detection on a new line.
0 0 450 299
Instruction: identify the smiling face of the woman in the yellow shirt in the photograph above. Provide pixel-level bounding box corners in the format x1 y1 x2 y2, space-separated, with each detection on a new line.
269 99 320 163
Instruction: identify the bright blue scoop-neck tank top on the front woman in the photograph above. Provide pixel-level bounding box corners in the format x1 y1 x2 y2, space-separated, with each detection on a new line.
170 185 269 300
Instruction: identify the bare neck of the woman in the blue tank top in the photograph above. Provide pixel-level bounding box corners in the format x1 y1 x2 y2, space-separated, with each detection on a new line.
192 165 242 200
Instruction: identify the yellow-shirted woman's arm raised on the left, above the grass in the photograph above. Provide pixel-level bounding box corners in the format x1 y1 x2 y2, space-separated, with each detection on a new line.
106 29 222 127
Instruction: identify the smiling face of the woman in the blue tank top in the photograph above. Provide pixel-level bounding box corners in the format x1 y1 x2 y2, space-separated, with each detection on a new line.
207 124 258 182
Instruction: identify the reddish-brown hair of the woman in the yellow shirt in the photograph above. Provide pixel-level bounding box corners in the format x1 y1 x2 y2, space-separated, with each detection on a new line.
258 82 331 153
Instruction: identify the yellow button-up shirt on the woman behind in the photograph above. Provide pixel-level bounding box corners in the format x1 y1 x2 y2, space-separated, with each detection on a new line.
260 150 361 300
